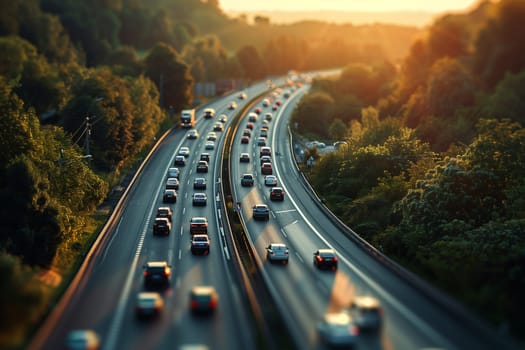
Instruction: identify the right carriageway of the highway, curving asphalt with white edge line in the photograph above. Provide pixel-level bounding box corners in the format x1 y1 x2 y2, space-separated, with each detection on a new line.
230 87 506 350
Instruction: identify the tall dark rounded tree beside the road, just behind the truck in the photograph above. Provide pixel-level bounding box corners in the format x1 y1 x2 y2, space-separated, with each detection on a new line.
144 43 193 109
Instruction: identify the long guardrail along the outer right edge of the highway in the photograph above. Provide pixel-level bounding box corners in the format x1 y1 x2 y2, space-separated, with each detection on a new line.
288 127 516 350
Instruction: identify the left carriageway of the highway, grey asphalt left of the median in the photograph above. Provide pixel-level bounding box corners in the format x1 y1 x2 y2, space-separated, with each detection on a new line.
32 80 266 350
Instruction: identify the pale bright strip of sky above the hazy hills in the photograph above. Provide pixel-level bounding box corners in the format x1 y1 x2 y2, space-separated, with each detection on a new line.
219 0 478 13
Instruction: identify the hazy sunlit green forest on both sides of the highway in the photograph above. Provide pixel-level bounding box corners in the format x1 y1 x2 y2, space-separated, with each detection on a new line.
0 0 525 349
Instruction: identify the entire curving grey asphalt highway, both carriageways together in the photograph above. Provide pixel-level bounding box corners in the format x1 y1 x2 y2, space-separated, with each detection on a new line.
31 77 516 350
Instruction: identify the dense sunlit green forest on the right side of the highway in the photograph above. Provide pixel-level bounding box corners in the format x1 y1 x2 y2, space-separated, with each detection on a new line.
293 0 525 340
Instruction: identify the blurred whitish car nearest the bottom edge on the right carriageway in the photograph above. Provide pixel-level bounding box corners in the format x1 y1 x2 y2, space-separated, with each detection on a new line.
317 312 359 348
